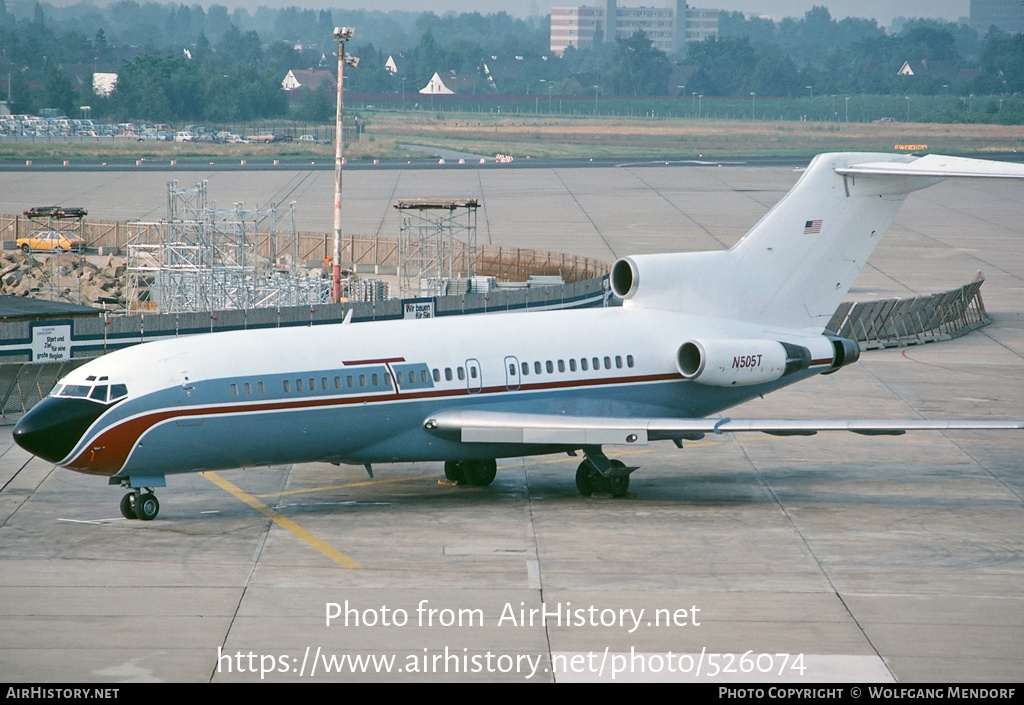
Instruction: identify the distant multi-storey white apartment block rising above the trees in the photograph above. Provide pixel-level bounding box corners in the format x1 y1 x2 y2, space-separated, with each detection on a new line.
551 0 720 56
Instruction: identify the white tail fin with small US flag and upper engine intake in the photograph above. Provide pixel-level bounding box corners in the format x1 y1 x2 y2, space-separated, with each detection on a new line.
611 153 1024 332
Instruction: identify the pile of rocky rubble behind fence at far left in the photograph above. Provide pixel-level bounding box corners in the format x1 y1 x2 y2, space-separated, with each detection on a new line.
0 250 125 306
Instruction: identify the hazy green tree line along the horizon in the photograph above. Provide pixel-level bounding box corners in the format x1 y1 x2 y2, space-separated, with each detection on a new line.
0 0 1024 122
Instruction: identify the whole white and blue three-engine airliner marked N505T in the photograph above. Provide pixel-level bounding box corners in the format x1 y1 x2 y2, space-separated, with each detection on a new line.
14 154 1024 520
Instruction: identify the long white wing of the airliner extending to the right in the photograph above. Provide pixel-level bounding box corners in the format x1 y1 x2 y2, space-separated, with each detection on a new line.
424 410 1024 446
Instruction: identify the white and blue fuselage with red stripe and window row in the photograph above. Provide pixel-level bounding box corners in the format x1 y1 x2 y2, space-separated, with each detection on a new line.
15 307 833 476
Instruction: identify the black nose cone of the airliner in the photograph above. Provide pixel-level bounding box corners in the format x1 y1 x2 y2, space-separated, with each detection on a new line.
13 397 104 463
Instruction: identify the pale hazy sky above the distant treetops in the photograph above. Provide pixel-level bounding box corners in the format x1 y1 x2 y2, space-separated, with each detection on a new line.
37 0 971 26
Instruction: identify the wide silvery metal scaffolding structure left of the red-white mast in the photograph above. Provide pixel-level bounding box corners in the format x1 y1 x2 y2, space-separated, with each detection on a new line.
127 181 331 313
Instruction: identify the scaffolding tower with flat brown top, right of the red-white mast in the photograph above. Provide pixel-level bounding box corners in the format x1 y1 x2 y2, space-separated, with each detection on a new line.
394 199 479 297
